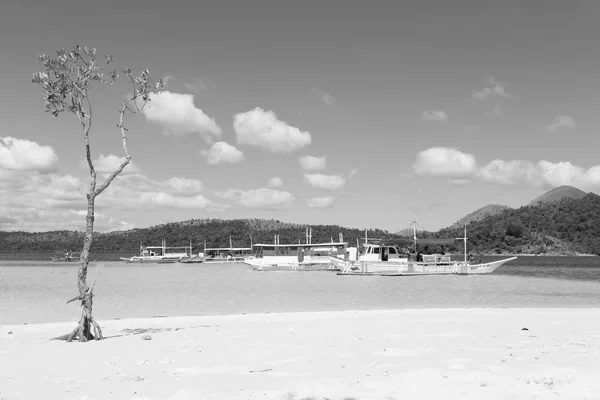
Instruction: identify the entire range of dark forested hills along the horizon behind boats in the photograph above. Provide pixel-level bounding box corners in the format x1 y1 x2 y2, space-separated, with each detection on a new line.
0 193 600 255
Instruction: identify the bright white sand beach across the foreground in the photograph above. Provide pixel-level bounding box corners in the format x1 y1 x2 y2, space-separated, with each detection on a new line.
0 309 600 400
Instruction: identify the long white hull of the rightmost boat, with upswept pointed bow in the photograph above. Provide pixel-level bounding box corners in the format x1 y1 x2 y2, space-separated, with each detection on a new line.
331 257 517 275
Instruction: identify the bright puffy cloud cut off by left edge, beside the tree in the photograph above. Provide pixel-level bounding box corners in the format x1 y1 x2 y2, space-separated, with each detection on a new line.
0 136 58 174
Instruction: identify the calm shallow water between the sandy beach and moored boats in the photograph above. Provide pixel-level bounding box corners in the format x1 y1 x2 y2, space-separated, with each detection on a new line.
0 257 600 324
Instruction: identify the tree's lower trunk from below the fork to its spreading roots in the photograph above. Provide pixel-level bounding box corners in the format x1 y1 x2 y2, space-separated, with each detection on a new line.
56 190 104 342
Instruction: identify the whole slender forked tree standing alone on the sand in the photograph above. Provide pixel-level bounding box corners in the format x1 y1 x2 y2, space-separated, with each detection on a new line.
32 46 164 342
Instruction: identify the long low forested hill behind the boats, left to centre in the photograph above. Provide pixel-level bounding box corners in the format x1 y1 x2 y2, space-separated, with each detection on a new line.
0 219 394 253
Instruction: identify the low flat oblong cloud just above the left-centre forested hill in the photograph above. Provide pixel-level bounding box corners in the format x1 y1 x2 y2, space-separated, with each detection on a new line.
216 188 295 210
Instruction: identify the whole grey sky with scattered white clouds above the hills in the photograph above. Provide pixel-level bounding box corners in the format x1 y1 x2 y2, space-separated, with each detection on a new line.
0 0 600 232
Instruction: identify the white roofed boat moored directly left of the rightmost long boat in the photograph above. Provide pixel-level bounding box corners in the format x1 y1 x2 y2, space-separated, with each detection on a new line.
245 230 347 271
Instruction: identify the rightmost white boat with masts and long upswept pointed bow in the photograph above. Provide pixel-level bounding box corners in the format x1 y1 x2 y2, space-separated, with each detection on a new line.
330 226 517 276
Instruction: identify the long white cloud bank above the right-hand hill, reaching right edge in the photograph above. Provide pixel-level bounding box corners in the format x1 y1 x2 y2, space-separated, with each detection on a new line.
413 147 600 189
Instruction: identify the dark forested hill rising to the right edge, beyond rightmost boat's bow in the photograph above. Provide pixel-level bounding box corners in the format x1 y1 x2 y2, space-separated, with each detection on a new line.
436 193 600 255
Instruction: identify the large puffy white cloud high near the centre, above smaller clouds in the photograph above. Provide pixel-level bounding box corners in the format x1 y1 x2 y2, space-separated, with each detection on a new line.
233 107 312 153
